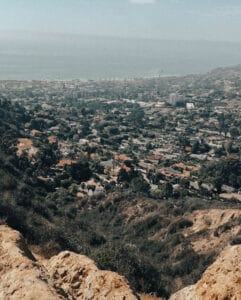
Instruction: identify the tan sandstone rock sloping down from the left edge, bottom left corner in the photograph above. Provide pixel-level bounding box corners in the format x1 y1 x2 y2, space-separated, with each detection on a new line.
0 225 60 300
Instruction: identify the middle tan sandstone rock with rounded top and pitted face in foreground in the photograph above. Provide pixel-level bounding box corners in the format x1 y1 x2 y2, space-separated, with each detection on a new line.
45 251 137 300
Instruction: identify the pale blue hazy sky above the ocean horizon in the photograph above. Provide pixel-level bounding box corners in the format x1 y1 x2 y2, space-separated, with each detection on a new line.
0 0 241 42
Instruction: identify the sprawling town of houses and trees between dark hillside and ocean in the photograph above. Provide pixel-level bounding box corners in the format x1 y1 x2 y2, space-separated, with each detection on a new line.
0 67 241 198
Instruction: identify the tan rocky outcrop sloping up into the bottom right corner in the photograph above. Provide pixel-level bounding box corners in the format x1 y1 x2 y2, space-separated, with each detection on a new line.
170 245 241 300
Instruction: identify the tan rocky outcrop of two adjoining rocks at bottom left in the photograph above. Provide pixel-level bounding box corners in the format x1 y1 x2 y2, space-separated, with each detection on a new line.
0 225 138 300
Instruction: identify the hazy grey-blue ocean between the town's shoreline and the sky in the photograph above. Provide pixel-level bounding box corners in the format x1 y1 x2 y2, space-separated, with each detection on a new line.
0 35 241 80
